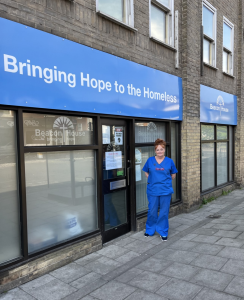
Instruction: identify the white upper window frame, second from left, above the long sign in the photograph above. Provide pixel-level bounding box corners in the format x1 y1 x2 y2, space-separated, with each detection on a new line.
149 0 174 47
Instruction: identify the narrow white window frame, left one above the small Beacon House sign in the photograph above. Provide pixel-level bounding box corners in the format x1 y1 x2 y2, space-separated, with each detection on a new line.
202 0 217 68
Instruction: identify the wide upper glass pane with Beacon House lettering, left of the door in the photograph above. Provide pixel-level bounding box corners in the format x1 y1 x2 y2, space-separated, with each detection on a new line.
23 113 93 146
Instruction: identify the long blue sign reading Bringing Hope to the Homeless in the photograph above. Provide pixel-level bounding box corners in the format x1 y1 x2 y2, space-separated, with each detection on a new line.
0 18 182 120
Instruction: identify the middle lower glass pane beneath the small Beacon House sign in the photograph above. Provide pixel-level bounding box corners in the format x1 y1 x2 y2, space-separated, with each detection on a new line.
217 143 228 185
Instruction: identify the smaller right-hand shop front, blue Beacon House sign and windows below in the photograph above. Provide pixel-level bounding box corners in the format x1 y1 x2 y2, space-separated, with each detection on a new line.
200 85 237 194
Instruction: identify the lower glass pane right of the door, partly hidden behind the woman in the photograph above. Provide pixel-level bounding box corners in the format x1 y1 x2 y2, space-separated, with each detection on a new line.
135 146 155 213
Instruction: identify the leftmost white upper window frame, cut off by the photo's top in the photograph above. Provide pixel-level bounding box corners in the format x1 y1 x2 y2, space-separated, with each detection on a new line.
96 0 137 31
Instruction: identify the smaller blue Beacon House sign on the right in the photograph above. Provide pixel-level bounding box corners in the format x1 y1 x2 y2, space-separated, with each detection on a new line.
200 85 237 125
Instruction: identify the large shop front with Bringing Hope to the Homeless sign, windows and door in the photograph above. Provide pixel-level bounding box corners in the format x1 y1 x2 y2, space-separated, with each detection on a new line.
0 15 182 269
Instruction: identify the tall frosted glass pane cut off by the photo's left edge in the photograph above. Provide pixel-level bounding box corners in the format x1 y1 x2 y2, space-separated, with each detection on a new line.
0 110 21 264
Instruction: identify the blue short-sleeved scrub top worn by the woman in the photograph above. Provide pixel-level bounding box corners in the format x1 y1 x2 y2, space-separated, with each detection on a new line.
142 156 178 196
